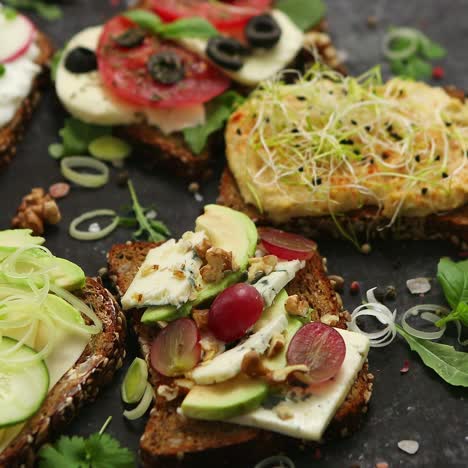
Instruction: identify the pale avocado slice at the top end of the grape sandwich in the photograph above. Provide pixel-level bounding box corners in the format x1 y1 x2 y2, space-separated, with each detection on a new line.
195 205 258 270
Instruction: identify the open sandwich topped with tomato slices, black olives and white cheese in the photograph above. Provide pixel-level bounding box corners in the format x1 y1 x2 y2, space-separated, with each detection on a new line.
56 0 339 178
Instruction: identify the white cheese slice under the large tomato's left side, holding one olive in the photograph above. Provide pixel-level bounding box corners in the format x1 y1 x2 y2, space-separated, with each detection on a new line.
55 26 205 134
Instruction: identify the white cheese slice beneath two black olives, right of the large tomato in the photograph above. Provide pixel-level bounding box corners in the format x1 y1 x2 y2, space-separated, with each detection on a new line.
179 10 304 86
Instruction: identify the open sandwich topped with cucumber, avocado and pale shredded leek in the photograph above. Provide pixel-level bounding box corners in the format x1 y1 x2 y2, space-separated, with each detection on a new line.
0 230 126 468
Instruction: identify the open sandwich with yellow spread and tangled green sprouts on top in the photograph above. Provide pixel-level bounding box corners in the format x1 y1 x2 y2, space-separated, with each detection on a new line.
219 67 468 248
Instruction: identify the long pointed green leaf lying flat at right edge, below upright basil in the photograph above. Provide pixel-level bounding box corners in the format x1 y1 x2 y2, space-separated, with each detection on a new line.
396 325 468 387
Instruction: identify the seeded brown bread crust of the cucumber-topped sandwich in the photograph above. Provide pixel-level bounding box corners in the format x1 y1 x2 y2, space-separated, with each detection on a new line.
0 278 126 468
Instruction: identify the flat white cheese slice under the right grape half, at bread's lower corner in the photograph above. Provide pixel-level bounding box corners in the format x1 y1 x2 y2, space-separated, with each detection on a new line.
229 329 369 441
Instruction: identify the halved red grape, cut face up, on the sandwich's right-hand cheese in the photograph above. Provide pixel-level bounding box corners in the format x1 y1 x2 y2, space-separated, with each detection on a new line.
287 322 346 383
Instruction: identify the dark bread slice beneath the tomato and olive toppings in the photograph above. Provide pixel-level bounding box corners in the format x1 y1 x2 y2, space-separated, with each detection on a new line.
110 0 343 180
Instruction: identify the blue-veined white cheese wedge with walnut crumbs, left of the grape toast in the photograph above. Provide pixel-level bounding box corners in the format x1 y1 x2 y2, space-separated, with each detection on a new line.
122 231 206 309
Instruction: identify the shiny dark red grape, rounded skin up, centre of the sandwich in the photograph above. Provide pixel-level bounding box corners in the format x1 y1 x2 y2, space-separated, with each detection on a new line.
208 283 263 343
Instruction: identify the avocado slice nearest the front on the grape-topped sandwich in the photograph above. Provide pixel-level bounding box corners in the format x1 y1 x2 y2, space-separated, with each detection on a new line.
182 374 268 421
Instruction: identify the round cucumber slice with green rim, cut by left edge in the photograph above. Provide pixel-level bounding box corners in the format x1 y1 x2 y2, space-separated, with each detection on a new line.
0 337 49 429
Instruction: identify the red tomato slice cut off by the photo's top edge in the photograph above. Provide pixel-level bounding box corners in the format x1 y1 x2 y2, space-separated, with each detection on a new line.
147 0 272 30
